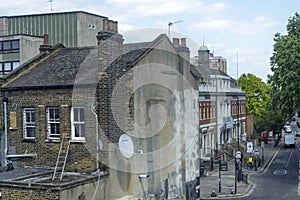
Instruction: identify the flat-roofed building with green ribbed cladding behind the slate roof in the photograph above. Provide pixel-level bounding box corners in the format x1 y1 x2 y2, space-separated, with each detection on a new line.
0 11 118 75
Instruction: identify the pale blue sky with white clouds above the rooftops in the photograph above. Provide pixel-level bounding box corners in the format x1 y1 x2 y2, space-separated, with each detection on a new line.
0 0 300 82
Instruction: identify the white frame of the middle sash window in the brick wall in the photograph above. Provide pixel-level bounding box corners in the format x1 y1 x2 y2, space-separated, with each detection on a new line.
47 107 60 139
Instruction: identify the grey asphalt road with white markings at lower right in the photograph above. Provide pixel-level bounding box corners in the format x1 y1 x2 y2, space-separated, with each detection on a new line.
243 121 300 200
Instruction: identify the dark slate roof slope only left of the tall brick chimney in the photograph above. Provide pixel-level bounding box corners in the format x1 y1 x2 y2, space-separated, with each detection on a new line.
4 47 98 89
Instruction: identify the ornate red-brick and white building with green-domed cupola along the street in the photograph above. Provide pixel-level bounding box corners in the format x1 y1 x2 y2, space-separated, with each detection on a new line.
194 46 246 161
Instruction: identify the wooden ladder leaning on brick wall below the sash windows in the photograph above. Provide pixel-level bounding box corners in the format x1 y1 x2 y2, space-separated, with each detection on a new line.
52 135 71 181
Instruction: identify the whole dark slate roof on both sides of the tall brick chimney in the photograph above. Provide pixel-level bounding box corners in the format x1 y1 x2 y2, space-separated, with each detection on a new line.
3 34 178 90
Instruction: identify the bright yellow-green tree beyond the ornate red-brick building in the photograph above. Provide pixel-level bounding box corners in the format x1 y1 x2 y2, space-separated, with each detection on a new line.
238 74 272 132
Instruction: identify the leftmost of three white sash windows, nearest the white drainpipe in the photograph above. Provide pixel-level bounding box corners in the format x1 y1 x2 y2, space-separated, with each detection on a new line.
23 108 35 139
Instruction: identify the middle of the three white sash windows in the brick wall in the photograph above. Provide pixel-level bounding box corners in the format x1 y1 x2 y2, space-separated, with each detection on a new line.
47 107 60 139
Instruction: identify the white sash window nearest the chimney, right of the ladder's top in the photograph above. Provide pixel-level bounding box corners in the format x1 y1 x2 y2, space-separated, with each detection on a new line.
71 107 85 140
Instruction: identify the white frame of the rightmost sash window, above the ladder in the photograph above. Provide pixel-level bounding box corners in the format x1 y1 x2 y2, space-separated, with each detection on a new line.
71 107 85 141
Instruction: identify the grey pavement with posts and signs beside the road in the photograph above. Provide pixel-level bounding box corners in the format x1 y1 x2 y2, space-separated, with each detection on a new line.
200 141 280 200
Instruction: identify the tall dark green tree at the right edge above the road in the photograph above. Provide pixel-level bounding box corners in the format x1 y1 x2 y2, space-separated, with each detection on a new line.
268 13 300 122
